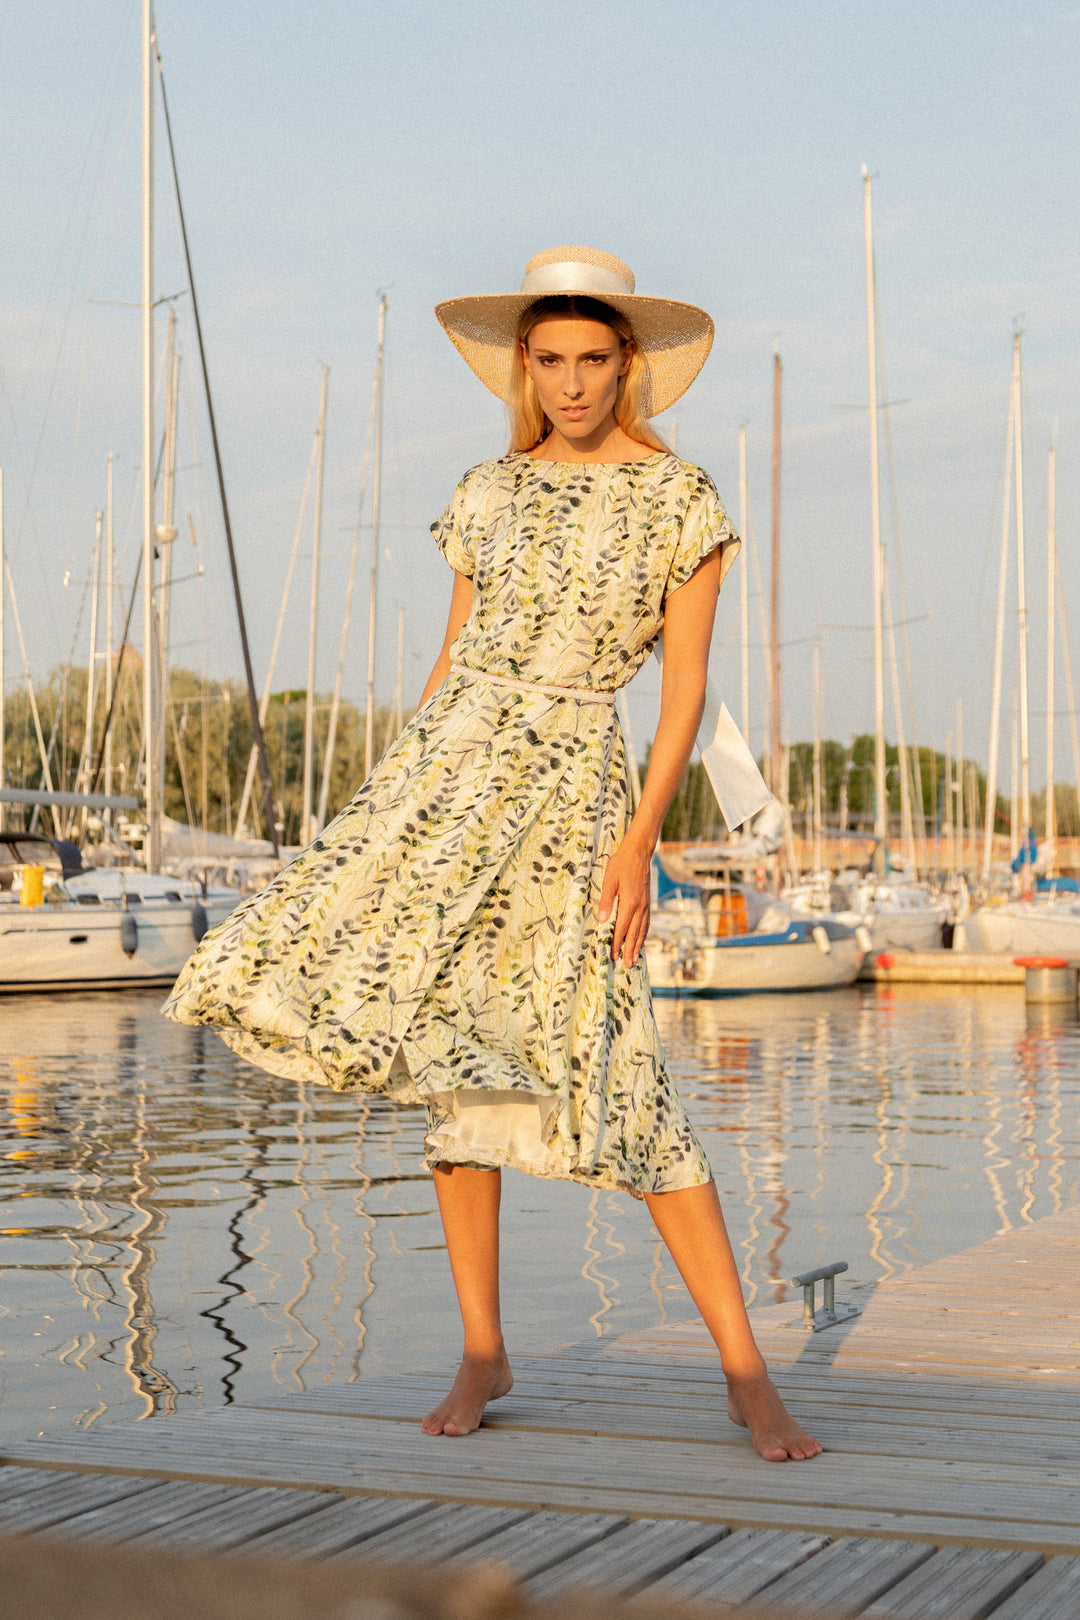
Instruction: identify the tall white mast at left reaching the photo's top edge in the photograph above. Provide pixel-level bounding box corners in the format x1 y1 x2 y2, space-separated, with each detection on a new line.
142 0 162 872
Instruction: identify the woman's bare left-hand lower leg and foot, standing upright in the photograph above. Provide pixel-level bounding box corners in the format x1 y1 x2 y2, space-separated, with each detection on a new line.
421 1165 513 1435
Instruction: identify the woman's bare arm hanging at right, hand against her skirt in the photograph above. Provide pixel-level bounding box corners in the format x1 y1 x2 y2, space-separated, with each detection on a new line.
599 548 721 967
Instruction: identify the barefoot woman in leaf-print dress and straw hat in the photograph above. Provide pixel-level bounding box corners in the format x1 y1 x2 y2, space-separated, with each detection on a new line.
168 248 821 1461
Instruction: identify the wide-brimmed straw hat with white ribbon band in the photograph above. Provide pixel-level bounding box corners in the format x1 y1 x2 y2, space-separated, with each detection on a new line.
436 246 714 416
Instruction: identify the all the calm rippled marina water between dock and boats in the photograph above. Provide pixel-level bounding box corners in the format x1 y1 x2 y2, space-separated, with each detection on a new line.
0 987 1080 1440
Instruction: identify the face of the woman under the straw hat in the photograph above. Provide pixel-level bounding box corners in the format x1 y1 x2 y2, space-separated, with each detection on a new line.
521 316 631 444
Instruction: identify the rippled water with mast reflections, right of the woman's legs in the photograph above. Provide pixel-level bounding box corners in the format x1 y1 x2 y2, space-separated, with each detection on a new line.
661 985 1080 1299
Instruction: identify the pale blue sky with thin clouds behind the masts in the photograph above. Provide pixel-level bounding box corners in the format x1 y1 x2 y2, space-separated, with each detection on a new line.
0 0 1080 781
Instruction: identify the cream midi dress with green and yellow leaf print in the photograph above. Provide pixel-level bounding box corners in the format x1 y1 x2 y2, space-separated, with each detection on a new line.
165 452 738 1196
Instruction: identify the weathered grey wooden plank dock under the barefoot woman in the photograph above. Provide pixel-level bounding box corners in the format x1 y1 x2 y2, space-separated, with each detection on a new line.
0 1209 1080 1620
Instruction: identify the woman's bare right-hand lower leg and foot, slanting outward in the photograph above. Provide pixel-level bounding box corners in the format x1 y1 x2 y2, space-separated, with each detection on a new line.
646 1183 821 1463
